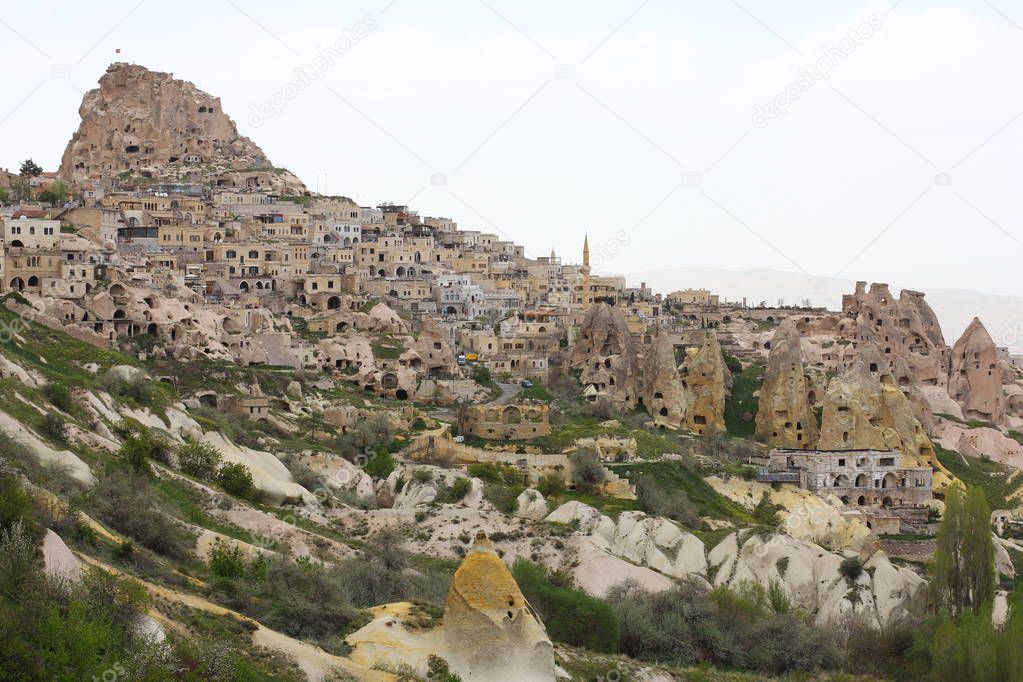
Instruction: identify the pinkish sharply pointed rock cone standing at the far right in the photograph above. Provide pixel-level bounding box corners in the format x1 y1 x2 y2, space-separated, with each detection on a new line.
948 317 1006 424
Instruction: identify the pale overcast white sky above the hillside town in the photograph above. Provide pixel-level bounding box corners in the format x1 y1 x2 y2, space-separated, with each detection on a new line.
0 0 1023 295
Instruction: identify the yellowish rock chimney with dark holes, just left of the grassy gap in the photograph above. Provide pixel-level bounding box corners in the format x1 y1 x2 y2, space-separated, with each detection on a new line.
679 331 731 434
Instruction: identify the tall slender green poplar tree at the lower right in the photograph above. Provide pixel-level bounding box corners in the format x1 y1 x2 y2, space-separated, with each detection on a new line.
931 487 994 619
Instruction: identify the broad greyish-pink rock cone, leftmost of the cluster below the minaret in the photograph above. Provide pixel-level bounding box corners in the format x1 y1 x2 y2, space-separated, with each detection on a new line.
570 302 639 408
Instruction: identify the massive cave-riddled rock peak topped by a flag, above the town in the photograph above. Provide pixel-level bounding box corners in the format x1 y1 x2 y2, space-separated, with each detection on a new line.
59 62 304 189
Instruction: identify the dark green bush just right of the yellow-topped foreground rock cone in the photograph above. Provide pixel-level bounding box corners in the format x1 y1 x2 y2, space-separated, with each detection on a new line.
512 557 619 653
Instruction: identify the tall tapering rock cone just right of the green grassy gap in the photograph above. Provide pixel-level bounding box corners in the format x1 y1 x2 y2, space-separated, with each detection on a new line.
756 319 819 449
